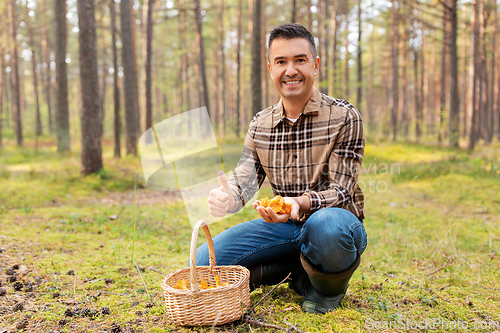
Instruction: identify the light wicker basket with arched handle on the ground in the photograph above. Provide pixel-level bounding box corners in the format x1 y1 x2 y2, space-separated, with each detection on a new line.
161 220 250 326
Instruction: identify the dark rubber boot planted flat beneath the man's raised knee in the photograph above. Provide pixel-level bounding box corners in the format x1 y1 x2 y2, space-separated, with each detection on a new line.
300 253 361 313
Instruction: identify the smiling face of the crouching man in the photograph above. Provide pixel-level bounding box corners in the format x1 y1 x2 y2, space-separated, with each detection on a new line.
267 38 319 102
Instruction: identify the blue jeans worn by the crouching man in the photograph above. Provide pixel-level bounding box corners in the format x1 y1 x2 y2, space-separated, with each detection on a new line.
196 208 367 273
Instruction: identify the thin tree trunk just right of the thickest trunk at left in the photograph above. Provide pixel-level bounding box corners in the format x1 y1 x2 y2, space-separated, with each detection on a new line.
109 0 122 157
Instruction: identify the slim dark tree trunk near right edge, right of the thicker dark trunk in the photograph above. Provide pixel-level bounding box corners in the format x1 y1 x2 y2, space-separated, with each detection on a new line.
468 0 481 150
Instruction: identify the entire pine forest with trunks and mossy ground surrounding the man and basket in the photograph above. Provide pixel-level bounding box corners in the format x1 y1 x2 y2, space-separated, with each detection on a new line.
0 0 500 332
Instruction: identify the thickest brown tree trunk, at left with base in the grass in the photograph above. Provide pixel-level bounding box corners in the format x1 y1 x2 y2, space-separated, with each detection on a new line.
78 0 102 174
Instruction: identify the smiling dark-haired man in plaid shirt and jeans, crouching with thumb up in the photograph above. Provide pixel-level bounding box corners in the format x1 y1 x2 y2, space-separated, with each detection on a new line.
197 24 367 313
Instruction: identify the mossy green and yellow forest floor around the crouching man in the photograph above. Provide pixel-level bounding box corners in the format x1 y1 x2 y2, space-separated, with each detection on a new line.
0 138 500 332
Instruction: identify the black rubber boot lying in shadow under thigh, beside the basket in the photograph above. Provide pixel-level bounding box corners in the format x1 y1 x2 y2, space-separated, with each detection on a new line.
248 259 310 290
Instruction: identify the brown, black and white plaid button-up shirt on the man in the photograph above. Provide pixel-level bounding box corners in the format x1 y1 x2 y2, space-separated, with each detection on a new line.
229 88 365 220
